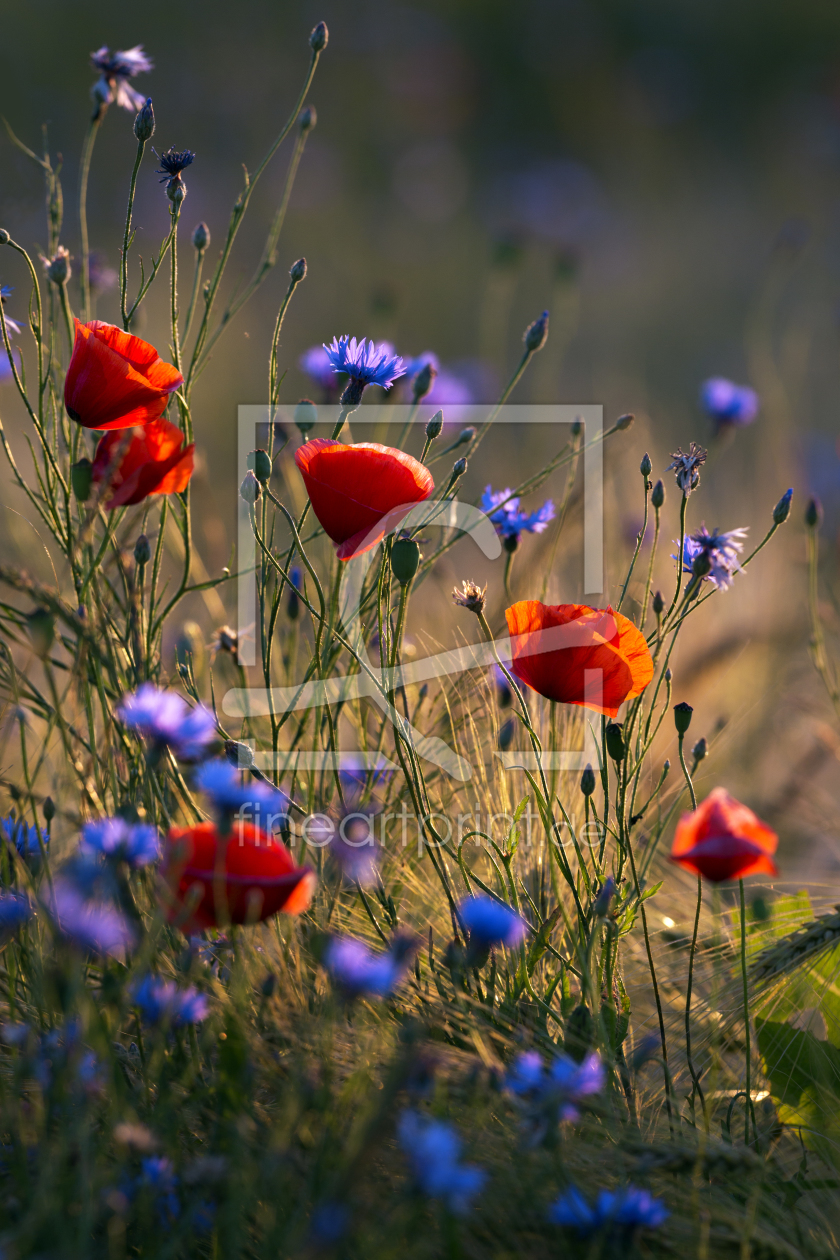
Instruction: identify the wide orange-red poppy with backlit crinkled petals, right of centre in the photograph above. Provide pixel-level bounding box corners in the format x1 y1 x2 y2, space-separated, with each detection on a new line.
505 600 654 717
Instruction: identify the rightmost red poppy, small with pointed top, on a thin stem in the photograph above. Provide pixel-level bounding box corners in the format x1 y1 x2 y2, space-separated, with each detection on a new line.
671 788 778 883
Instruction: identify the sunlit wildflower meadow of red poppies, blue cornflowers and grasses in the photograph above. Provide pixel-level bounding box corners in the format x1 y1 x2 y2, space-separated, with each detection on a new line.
0 12 840 1260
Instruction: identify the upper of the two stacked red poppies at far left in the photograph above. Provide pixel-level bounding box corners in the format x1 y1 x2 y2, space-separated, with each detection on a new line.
64 319 184 428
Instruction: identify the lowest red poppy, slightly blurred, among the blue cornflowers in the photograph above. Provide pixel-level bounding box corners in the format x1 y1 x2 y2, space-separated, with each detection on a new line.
161 822 315 931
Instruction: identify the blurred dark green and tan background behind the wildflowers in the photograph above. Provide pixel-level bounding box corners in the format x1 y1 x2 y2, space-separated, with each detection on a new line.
0 0 840 882
